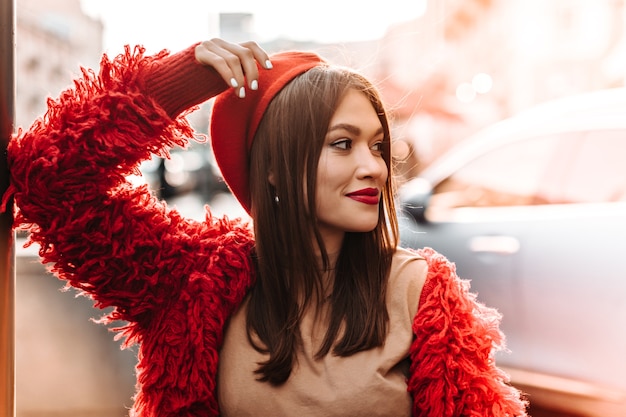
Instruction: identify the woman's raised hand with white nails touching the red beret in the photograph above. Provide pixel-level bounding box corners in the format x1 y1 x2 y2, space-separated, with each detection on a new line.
195 39 272 98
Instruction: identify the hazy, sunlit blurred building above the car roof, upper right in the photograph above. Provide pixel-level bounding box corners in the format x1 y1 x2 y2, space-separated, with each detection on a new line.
370 0 626 170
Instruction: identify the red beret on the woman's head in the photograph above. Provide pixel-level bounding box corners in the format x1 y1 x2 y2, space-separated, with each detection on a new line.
211 52 324 213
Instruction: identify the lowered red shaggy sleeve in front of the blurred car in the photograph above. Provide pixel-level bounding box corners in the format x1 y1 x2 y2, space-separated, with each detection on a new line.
408 248 527 417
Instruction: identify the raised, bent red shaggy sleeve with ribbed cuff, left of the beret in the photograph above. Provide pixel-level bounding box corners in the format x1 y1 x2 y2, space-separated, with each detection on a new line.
3 43 239 334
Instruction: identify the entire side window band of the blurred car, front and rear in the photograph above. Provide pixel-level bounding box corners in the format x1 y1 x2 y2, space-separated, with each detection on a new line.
429 130 626 213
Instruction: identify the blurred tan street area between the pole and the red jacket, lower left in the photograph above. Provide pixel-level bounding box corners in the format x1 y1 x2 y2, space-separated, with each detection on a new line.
15 239 136 417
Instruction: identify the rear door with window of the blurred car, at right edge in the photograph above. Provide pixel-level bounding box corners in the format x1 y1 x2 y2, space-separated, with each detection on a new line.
516 129 626 395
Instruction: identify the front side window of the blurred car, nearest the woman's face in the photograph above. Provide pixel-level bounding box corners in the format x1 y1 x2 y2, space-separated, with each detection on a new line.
429 135 564 211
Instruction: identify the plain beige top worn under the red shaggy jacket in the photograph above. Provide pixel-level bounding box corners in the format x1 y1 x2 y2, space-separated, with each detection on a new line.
218 249 427 417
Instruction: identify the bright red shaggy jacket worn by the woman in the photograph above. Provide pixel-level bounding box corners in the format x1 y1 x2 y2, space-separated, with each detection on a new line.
3 47 525 417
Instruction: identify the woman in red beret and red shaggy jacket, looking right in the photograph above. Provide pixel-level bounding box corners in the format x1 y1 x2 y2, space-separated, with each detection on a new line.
4 39 526 416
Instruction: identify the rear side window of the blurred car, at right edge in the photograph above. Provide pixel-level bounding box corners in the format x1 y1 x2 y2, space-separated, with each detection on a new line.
541 130 626 203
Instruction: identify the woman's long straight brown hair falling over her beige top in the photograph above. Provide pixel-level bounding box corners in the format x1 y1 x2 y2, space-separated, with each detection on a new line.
247 66 398 385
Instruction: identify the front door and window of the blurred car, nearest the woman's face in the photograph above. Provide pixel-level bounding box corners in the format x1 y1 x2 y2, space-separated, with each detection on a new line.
401 135 570 368
